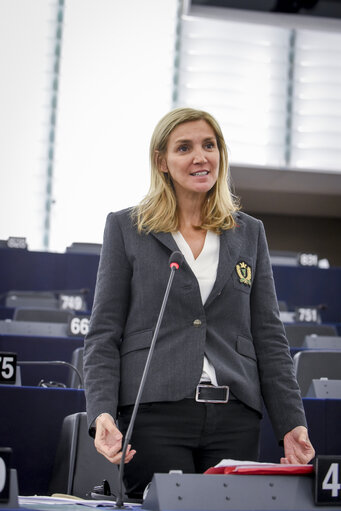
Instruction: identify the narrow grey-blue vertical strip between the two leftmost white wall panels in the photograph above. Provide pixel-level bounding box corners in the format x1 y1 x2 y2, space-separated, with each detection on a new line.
43 0 65 250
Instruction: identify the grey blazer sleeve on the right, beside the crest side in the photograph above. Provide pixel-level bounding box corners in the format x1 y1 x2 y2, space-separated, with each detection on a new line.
251 221 307 440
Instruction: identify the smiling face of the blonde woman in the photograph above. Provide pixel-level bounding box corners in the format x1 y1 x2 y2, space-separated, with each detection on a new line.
160 120 220 198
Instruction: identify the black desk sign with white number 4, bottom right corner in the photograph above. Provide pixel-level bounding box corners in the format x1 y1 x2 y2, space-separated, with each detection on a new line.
315 456 341 506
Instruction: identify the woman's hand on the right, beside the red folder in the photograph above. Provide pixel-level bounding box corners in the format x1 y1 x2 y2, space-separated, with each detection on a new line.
281 426 315 465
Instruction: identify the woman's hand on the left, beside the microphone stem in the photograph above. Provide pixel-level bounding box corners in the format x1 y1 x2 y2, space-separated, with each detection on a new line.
95 413 136 465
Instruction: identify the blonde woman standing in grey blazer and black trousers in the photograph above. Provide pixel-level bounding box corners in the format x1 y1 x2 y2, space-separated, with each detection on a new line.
84 108 314 497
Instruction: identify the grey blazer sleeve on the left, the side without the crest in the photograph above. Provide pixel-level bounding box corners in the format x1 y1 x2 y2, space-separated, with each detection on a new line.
83 213 132 432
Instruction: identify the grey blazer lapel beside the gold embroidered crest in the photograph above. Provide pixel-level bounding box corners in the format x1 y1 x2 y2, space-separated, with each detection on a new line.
205 215 244 307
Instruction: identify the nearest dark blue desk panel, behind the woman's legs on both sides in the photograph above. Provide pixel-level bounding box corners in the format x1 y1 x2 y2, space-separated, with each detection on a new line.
0 386 341 495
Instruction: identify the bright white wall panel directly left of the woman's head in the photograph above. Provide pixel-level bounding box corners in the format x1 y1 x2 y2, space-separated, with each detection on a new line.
51 0 177 249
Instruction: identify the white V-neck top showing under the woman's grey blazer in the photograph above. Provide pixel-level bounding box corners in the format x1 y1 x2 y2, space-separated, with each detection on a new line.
172 231 220 385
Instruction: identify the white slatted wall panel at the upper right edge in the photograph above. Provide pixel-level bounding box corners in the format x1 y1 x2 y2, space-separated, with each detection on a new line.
291 28 341 172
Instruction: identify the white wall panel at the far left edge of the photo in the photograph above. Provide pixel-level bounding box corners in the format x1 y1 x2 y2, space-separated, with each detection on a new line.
0 0 55 247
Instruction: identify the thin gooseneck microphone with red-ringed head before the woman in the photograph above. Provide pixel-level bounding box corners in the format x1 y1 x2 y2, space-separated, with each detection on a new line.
115 250 184 509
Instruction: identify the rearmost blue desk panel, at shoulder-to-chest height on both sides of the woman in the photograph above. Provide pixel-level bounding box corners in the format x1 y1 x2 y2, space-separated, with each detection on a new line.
0 249 341 323
